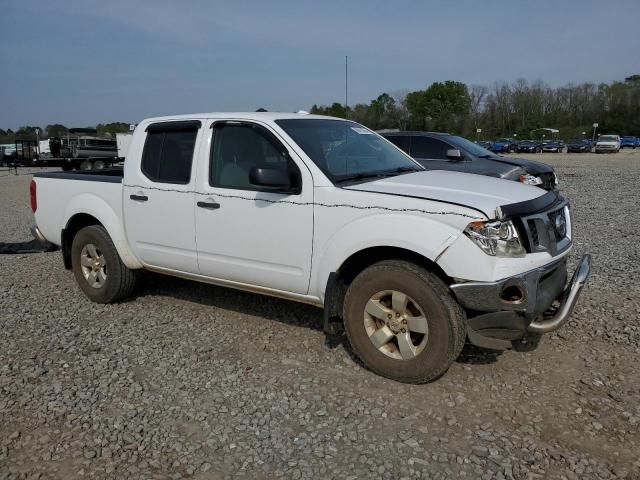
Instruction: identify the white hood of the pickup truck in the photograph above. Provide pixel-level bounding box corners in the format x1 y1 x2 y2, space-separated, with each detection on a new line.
344 170 546 218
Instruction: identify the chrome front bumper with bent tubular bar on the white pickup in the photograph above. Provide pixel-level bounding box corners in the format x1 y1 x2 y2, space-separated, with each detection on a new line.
450 255 591 350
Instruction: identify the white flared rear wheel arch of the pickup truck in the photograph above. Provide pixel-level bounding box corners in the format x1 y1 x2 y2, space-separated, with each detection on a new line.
63 193 142 269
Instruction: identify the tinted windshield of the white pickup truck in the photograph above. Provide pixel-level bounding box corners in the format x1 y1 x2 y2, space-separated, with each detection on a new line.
276 118 424 183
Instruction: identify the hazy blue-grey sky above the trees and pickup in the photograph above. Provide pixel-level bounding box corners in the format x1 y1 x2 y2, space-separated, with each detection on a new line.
0 0 640 130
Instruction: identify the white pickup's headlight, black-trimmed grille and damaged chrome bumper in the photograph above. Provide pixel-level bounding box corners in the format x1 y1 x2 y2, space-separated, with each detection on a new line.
450 192 591 350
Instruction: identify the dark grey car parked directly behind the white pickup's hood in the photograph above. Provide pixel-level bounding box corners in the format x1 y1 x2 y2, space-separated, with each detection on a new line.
379 131 557 190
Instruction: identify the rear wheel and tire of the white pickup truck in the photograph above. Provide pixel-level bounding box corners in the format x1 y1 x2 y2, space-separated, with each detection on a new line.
71 225 138 303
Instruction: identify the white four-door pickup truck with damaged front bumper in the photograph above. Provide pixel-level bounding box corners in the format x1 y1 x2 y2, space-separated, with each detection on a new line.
31 113 590 383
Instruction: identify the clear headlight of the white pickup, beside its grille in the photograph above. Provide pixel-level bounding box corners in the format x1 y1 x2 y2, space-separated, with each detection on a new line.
464 220 527 257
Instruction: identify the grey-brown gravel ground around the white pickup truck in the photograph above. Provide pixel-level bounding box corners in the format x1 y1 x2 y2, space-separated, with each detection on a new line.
0 155 640 479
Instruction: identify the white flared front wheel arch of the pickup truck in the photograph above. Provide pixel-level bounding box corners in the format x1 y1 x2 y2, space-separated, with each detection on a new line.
309 213 461 301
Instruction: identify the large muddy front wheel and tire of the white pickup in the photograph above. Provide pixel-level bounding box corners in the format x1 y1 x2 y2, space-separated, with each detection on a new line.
343 260 466 383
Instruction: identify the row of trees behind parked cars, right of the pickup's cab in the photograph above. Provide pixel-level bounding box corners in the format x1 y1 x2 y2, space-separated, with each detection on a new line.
310 75 640 138
